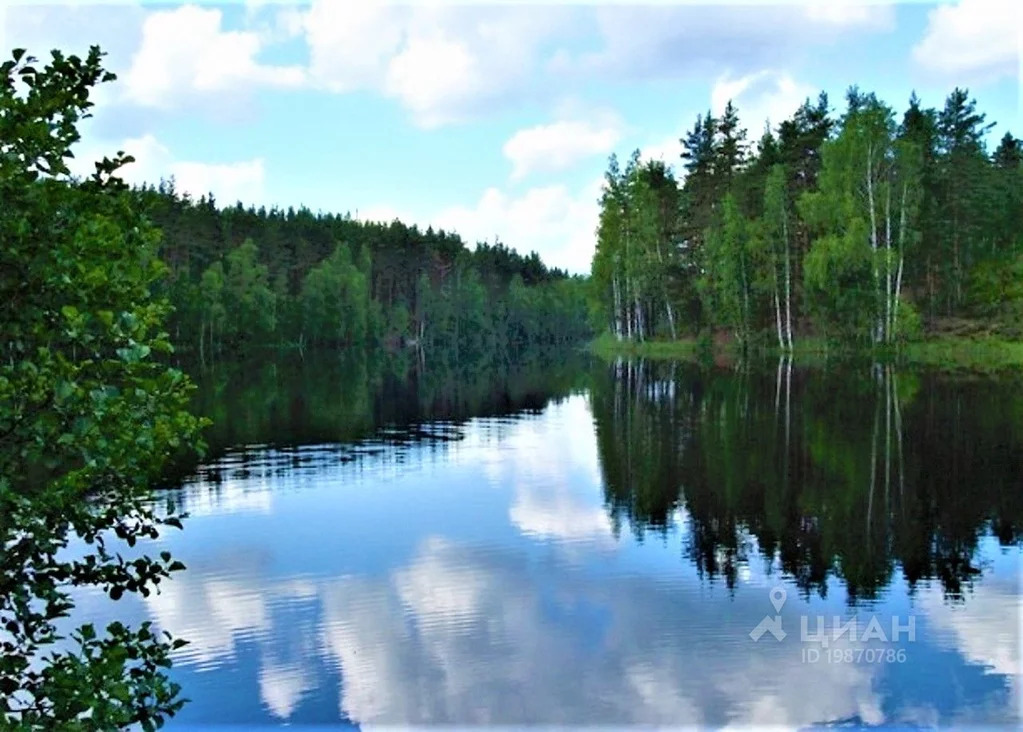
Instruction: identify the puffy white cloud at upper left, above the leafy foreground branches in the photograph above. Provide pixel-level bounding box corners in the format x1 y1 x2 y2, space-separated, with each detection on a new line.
122 5 305 109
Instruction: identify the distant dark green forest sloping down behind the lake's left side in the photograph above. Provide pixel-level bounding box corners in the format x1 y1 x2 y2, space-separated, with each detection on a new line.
139 189 589 359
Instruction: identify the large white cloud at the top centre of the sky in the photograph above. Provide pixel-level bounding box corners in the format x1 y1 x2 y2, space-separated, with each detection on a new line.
304 0 575 128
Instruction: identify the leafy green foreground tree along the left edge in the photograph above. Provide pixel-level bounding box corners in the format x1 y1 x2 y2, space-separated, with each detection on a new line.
0 47 202 730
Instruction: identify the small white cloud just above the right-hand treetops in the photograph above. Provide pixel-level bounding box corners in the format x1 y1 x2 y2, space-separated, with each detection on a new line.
710 71 815 142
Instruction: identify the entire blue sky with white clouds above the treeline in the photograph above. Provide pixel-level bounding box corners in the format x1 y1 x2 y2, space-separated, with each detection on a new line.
0 0 1023 272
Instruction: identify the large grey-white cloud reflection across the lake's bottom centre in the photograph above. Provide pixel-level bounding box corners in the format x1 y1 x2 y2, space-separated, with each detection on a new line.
324 540 884 724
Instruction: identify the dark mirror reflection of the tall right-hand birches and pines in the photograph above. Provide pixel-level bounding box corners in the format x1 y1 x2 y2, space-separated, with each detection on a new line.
592 361 1023 601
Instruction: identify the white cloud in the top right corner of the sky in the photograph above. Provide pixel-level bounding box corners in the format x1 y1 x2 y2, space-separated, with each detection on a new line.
913 0 1023 82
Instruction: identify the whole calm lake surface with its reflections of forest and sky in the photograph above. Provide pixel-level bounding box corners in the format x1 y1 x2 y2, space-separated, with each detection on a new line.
68 355 1023 728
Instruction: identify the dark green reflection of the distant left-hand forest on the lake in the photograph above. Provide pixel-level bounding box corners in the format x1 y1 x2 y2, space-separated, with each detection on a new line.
180 350 587 457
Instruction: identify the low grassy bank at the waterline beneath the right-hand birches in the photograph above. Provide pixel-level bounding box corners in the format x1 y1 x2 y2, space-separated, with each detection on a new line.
588 333 1023 372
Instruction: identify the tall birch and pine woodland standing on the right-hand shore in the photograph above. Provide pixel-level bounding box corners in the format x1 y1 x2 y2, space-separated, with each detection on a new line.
592 88 1023 351
